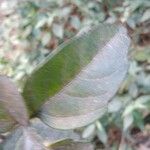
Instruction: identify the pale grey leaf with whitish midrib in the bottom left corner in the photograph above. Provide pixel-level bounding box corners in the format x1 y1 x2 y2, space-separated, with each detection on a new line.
2 127 46 150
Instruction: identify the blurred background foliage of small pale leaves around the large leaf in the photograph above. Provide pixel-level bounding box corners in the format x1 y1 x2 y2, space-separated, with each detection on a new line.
0 0 150 150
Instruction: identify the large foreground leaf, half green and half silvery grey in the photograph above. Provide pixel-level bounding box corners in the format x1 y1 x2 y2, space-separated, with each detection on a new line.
23 24 130 129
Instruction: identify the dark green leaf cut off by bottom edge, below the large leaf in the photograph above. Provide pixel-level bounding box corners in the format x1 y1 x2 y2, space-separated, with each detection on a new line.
50 141 94 150
